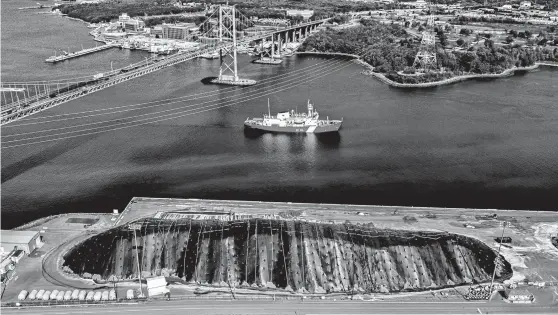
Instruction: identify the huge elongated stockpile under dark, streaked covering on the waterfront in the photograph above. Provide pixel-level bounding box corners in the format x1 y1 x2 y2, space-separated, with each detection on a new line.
64 219 511 293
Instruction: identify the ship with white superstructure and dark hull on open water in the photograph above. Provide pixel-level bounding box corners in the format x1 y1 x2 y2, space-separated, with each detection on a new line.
244 100 343 133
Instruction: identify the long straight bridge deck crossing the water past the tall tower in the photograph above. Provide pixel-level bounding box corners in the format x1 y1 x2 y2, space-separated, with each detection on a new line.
0 19 328 125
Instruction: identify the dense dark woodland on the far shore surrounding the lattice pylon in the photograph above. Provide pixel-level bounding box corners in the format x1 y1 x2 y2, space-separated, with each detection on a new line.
300 20 558 83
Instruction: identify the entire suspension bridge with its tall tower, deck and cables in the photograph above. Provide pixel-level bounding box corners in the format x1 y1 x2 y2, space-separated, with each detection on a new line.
0 5 328 126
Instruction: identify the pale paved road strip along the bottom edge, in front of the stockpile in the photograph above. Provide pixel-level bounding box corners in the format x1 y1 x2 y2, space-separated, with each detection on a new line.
2 300 558 315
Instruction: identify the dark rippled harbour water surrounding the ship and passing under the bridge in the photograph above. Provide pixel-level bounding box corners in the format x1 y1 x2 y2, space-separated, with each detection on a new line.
2 0 558 228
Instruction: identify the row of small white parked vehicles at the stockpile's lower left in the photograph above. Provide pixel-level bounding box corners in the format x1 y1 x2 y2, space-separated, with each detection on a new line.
17 289 134 301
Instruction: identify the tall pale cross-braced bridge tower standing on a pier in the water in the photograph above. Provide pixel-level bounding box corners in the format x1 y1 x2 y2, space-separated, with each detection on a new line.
212 4 256 85
